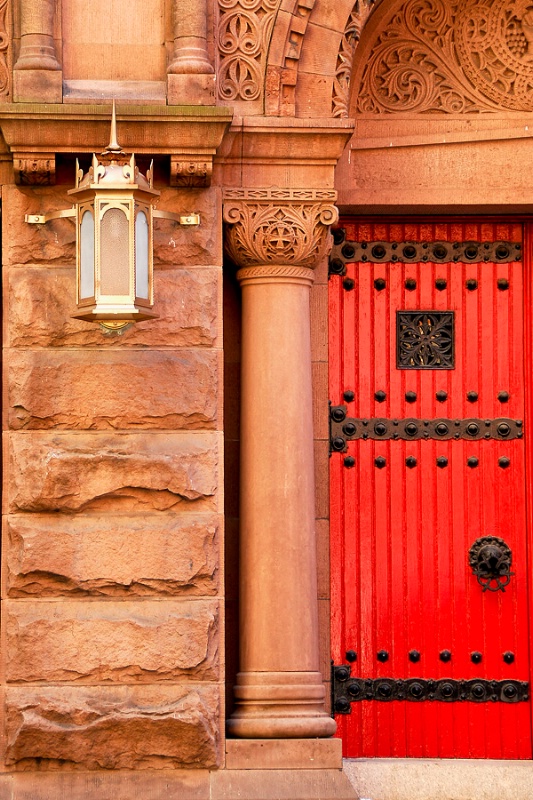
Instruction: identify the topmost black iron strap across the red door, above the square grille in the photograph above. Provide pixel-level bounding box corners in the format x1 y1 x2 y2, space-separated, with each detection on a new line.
329 234 522 275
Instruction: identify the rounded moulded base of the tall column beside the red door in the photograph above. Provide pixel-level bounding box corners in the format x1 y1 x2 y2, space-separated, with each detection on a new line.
227 672 336 739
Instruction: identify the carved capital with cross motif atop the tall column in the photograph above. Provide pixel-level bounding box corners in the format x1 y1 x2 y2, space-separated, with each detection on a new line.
224 189 338 268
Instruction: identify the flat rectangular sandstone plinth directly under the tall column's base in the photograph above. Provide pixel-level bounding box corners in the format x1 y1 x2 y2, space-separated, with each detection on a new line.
226 739 342 770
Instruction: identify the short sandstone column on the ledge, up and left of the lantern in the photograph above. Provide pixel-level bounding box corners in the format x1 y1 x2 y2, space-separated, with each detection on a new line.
13 0 63 103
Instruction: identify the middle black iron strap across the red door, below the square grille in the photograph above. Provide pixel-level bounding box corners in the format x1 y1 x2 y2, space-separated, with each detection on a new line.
330 406 524 453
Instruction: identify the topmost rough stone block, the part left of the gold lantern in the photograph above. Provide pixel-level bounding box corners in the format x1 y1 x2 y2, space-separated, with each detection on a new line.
2 186 76 266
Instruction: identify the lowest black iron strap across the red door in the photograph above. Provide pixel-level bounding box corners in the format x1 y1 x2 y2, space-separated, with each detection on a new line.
333 666 529 714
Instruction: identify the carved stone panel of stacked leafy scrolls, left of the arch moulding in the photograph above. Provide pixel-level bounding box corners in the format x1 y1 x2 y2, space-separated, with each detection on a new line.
218 0 281 100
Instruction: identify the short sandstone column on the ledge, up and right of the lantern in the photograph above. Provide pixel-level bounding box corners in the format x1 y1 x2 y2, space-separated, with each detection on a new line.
167 0 215 105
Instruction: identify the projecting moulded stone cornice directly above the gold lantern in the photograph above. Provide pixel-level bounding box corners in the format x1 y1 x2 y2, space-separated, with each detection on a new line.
0 103 232 186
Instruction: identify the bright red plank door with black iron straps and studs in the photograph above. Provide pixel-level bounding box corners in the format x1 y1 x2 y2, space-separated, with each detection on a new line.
329 220 532 759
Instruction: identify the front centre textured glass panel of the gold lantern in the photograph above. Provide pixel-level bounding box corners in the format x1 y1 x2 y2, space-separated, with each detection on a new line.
100 208 130 296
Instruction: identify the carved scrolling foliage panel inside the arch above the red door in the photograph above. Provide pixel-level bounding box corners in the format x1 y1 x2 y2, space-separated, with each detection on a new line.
356 0 533 114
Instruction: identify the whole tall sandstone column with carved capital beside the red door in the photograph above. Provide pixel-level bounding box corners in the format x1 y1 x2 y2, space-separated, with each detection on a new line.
224 190 337 739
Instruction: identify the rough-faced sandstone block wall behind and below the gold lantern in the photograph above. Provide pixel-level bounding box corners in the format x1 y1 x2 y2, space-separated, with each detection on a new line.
0 186 224 771
